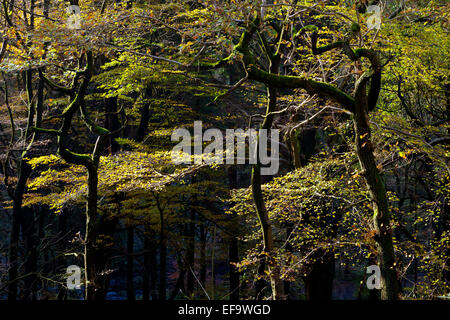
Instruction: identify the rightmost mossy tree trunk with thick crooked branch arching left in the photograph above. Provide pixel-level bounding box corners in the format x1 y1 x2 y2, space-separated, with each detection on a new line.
197 6 398 299
